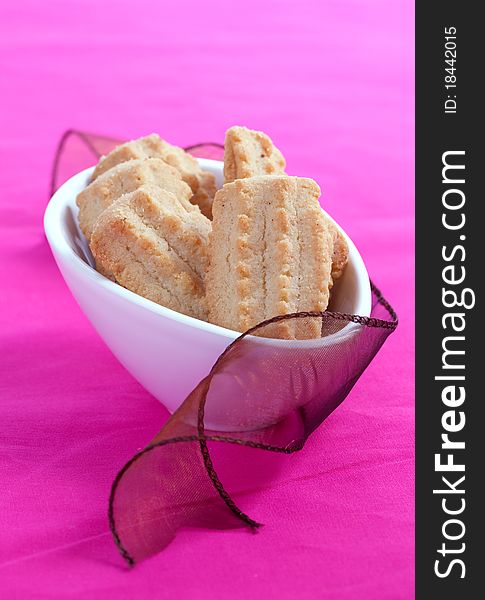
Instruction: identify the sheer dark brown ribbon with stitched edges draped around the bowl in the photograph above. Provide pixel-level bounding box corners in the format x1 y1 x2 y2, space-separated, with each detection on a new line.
51 131 398 565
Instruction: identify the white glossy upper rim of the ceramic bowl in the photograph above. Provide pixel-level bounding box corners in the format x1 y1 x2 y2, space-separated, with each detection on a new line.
43 158 371 345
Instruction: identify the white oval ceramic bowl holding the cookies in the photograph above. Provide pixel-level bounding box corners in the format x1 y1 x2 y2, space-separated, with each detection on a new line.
44 159 371 429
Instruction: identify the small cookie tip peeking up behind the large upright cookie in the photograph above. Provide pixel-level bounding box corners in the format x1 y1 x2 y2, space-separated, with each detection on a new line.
224 126 286 183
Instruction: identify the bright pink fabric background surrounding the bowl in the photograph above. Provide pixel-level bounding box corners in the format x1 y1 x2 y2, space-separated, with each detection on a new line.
0 0 414 600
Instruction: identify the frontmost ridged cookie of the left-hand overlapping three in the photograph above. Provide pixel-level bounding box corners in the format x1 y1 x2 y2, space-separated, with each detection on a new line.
90 185 211 320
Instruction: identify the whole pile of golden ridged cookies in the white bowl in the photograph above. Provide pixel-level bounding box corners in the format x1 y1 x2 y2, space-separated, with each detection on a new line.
77 127 348 339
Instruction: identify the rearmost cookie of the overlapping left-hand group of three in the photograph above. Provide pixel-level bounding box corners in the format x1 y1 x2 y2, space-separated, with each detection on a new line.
93 133 216 218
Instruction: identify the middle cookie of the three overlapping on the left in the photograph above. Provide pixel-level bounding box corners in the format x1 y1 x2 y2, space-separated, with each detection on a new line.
76 158 192 241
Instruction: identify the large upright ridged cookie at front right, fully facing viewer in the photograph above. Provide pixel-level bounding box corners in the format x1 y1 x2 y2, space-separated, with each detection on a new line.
206 175 333 339
